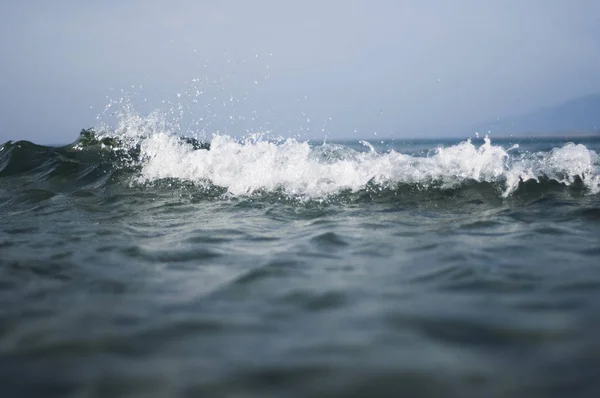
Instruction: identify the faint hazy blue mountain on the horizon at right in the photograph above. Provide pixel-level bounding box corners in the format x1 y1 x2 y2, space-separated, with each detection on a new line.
475 94 600 137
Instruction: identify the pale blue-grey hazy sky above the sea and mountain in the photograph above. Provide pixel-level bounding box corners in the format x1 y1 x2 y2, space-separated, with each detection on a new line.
0 0 600 143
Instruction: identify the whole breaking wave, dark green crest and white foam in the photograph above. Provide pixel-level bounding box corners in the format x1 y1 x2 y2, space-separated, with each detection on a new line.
0 128 600 199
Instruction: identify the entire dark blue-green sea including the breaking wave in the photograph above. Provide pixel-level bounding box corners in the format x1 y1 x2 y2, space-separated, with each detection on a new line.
0 115 600 398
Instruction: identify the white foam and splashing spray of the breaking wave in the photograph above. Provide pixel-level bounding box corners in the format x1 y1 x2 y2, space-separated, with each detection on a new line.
91 112 600 199
